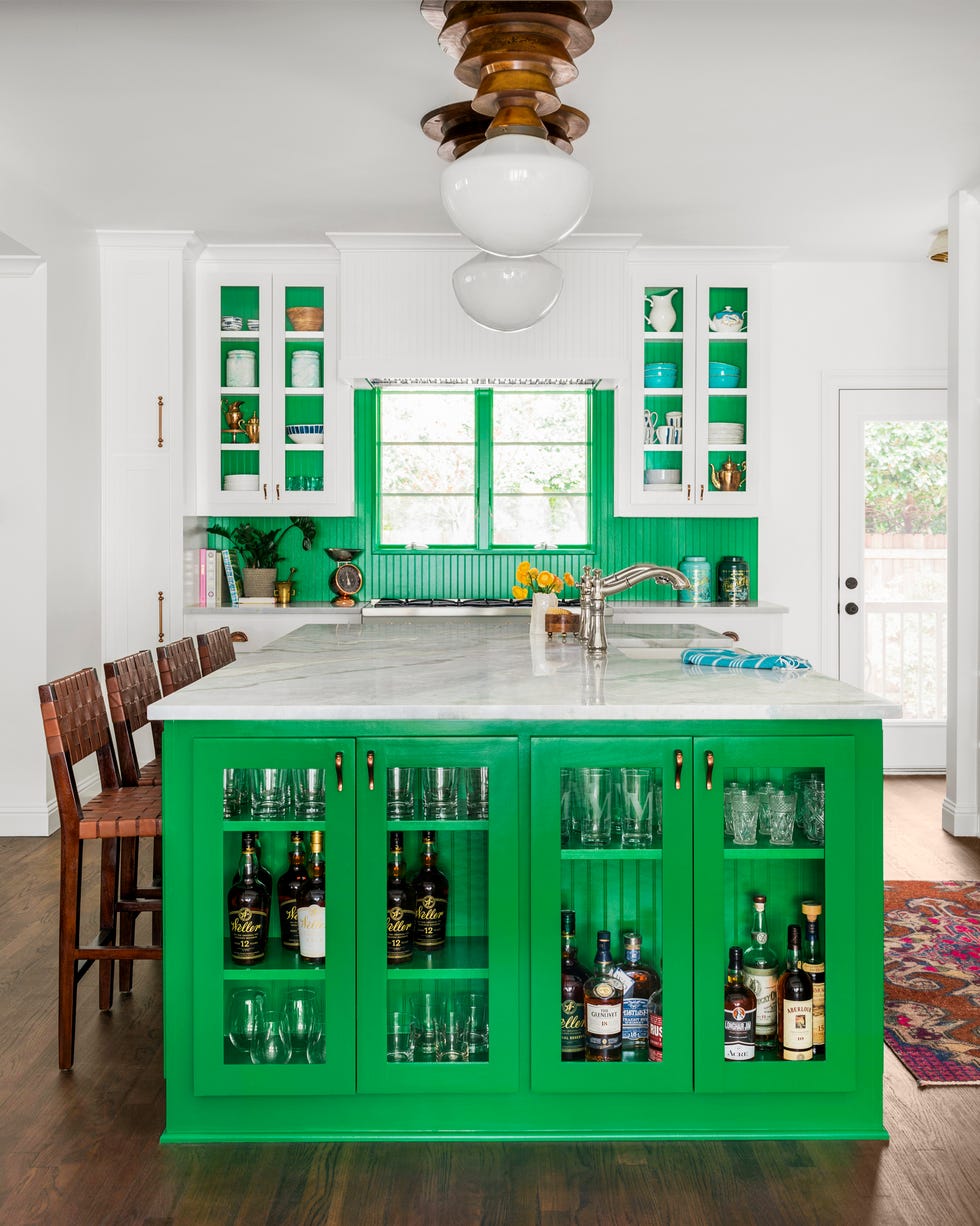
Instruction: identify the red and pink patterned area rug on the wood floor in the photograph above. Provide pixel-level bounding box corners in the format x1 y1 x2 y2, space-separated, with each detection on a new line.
884 881 980 1087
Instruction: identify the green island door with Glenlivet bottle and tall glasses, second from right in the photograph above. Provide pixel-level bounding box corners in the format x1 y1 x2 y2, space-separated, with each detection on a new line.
531 737 692 1093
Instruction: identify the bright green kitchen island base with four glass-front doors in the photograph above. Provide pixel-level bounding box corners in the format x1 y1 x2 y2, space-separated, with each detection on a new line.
163 721 886 1141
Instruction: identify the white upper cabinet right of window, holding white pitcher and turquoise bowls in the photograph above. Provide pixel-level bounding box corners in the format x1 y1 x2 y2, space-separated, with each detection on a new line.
616 265 767 516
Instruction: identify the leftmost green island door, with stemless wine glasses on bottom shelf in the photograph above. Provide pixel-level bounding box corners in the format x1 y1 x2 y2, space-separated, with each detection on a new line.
186 739 357 1095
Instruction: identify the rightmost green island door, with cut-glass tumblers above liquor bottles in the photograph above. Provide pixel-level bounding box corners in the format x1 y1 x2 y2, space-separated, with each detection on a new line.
693 736 858 1095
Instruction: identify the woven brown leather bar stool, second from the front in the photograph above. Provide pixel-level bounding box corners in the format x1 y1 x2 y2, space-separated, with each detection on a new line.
104 651 163 966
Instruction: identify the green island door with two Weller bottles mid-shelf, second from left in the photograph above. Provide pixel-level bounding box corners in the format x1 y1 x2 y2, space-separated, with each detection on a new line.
357 737 521 1093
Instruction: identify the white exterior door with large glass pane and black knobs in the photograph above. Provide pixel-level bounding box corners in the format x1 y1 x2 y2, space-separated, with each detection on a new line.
838 389 947 772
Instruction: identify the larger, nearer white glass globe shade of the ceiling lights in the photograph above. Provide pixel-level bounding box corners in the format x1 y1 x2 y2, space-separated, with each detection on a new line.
442 135 592 255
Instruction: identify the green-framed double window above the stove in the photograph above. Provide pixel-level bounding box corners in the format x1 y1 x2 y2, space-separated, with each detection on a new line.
374 384 596 553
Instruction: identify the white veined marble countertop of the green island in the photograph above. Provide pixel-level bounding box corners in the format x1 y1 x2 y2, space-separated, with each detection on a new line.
150 617 899 721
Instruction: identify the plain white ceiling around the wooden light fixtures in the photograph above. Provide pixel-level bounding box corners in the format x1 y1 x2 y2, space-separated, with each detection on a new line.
0 0 980 260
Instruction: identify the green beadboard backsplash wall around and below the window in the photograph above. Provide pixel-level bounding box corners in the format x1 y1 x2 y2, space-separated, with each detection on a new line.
209 391 758 601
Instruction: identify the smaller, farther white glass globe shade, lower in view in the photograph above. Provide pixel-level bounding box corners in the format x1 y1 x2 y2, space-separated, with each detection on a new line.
453 251 564 332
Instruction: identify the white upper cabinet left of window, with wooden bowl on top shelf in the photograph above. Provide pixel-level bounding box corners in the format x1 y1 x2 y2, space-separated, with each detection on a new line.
197 260 353 515
